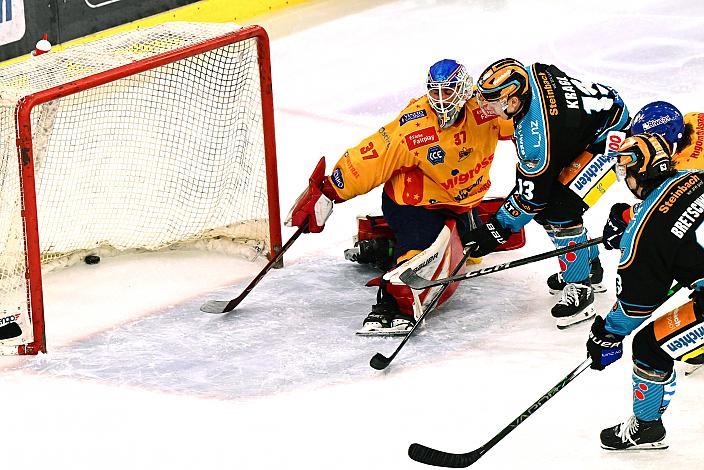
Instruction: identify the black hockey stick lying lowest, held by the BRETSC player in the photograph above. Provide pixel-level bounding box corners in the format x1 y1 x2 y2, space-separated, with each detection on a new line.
408 358 592 468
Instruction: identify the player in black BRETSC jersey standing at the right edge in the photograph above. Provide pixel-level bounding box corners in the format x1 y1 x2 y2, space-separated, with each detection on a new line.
587 134 704 450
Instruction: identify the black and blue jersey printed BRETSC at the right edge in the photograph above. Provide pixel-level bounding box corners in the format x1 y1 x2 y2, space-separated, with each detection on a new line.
606 171 704 335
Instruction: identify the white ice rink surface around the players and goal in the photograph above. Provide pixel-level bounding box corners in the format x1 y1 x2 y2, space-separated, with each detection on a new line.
0 0 704 470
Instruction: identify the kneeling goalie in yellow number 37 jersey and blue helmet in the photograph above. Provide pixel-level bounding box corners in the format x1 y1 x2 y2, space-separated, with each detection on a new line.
286 59 513 335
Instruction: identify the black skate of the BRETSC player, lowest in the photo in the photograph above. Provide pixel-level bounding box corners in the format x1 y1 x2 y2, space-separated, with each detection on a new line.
599 416 668 450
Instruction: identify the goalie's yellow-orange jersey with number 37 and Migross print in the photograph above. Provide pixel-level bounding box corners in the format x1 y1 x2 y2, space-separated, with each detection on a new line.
328 96 513 213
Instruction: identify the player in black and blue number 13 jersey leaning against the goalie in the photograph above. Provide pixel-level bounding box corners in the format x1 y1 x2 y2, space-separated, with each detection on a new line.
466 59 629 328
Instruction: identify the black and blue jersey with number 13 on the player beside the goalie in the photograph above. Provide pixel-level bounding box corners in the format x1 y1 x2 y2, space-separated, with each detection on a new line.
497 63 629 232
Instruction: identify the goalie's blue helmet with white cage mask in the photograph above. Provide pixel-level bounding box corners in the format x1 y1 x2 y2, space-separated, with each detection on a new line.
426 59 472 128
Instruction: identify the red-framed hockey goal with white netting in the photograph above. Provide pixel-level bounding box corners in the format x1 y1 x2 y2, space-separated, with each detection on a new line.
0 23 281 354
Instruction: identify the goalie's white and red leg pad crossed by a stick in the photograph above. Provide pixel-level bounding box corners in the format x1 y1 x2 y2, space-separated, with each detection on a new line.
384 225 452 320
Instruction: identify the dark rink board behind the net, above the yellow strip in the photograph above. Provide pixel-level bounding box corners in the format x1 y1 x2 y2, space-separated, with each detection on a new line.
0 0 198 61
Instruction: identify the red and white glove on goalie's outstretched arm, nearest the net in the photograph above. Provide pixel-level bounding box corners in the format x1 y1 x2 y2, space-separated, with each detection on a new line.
285 157 332 233
